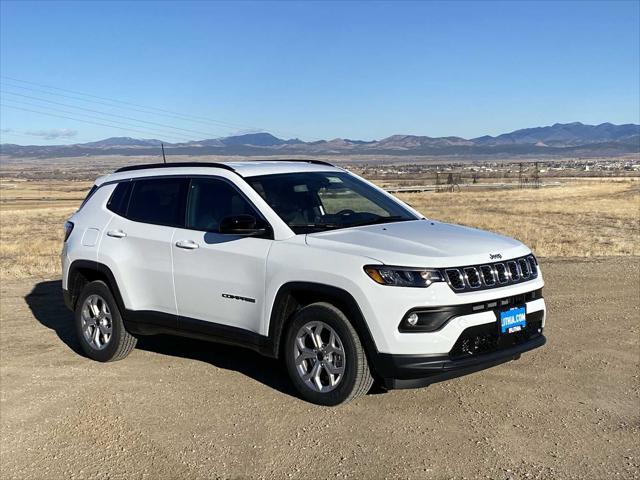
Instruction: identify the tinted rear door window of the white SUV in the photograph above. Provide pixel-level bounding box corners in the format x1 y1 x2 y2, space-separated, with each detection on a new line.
127 178 189 227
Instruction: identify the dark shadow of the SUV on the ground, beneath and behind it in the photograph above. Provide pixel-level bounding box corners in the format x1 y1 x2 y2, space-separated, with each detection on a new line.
25 280 297 396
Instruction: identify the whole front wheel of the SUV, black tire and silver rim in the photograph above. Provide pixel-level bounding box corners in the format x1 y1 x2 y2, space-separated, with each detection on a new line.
284 303 373 405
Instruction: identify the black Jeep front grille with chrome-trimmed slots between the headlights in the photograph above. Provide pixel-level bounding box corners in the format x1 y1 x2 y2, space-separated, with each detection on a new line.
442 255 538 293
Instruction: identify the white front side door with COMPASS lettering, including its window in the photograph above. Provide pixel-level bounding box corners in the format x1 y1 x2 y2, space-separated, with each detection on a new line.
172 177 273 333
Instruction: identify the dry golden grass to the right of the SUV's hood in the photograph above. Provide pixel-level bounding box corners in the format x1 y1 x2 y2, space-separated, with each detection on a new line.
398 181 640 257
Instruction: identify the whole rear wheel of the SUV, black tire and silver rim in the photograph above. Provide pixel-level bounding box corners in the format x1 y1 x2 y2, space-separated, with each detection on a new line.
75 280 137 362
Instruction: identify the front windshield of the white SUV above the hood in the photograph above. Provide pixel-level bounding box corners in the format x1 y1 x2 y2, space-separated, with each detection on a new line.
247 172 418 233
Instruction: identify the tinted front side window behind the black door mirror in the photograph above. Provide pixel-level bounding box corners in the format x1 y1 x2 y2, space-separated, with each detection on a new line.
187 178 261 232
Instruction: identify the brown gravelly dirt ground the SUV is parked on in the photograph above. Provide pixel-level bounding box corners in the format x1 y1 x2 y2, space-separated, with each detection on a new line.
0 258 640 479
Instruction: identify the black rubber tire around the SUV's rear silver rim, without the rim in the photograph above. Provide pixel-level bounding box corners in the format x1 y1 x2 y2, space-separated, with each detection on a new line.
75 280 138 362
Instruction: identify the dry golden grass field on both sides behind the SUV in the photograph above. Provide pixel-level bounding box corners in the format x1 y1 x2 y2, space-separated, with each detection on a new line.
0 178 640 278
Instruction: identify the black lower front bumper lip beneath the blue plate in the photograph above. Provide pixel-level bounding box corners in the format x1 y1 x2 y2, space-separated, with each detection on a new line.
376 334 546 389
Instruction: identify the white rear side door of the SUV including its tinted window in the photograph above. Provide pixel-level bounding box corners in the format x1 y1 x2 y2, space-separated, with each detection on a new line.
100 177 189 320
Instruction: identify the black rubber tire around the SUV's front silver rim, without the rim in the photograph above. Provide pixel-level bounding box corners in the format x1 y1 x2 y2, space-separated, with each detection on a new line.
283 302 373 406
